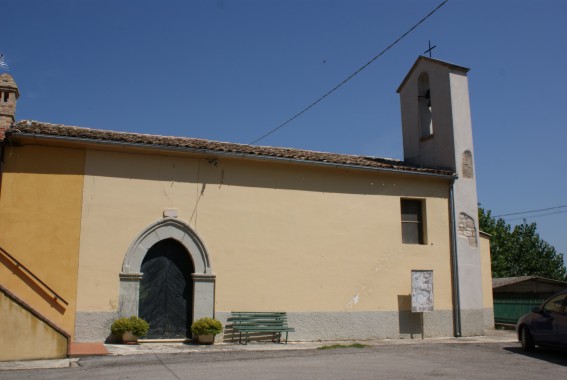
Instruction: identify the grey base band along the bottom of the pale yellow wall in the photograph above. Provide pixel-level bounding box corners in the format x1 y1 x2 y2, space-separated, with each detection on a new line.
75 309 494 342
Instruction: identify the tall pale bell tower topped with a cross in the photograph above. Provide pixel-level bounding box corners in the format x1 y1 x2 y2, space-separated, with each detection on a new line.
398 56 491 336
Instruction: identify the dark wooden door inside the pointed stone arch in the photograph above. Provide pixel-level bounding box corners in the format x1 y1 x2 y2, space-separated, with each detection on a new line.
139 239 194 339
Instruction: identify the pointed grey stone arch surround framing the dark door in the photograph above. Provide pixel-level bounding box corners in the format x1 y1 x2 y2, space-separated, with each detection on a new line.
119 218 215 336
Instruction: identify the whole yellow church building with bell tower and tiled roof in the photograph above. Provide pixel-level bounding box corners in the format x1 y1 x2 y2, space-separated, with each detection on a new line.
0 56 493 360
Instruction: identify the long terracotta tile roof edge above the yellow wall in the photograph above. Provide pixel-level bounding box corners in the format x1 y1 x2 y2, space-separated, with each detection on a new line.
6 120 453 176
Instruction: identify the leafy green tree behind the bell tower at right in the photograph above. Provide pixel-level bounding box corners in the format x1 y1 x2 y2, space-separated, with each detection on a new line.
478 207 567 280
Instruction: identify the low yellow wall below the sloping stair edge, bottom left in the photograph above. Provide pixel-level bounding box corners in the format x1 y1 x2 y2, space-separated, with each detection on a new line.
0 291 68 361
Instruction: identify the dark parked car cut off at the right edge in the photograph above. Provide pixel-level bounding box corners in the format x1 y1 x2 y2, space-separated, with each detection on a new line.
516 289 567 351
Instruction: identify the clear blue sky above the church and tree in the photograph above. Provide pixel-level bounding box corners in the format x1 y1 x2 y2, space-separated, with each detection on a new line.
0 0 567 262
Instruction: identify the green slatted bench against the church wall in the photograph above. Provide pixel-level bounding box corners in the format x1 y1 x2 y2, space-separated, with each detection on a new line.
227 311 295 344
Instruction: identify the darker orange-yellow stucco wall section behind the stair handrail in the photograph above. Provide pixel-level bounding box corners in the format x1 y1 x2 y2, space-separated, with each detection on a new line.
0 145 84 335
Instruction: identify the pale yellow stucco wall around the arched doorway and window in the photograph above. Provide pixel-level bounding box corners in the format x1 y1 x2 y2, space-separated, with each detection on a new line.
77 150 452 312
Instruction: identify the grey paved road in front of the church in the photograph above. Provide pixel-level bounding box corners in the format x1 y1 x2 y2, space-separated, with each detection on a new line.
0 343 567 380
